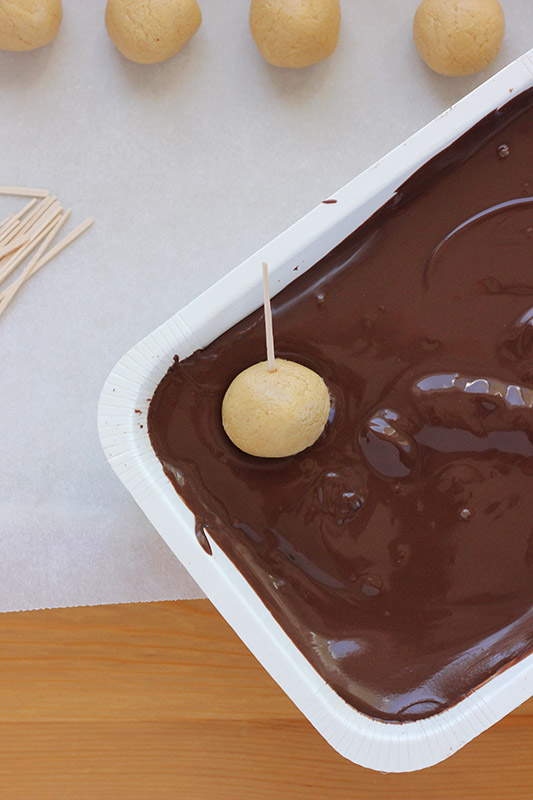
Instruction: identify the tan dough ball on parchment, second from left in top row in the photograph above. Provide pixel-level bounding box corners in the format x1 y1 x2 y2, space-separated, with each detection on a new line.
105 0 202 64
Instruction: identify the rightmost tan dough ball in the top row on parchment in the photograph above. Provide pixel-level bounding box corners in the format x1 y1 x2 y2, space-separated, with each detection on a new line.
413 0 505 75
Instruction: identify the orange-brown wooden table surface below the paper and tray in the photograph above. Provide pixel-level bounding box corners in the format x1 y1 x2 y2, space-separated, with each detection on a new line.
0 600 533 800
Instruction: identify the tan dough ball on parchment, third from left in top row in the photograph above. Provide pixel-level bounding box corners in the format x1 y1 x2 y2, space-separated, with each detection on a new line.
250 0 341 67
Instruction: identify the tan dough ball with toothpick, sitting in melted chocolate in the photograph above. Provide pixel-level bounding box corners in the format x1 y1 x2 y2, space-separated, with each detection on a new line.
222 358 331 458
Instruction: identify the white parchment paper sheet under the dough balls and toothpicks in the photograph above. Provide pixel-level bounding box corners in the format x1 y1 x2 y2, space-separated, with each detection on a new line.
0 0 533 611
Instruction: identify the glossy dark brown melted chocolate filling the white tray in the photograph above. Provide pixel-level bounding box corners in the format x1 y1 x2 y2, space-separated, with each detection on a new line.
149 90 533 721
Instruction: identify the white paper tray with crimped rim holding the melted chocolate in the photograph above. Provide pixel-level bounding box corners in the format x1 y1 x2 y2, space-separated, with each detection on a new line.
98 50 533 772
